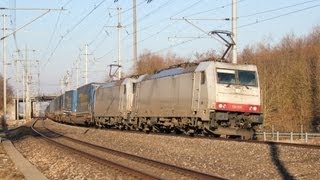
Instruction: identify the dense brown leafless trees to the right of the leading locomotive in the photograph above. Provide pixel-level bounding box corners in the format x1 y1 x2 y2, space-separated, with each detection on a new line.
240 26 320 132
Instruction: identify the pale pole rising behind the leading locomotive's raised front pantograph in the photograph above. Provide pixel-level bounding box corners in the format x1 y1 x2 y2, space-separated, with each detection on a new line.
232 0 238 64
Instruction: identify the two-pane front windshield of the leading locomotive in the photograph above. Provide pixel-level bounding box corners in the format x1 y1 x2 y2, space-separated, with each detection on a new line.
217 69 257 86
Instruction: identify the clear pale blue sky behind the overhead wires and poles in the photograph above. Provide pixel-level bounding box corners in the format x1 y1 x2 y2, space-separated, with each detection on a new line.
0 0 320 93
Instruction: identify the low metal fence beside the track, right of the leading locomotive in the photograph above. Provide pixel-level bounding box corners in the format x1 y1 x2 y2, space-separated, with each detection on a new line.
256 132 320 144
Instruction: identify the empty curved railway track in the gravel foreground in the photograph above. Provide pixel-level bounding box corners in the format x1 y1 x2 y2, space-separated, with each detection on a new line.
32 121 224 179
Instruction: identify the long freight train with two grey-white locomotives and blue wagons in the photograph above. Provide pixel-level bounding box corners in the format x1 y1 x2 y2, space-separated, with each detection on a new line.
46 61 263 139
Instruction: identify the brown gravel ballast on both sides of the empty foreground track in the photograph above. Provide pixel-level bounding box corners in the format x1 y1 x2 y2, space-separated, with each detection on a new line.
5 120 320 179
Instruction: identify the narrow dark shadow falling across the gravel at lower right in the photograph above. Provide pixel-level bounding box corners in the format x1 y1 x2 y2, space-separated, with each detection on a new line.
269 142 295 180
